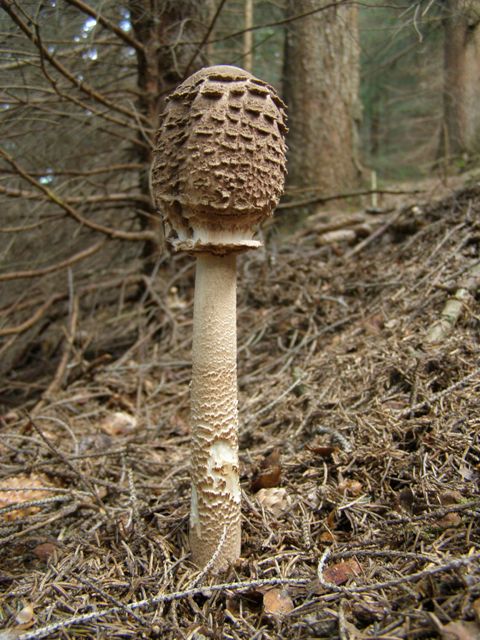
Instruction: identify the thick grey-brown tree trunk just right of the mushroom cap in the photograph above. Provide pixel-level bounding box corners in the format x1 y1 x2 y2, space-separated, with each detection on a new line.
284 0 360 216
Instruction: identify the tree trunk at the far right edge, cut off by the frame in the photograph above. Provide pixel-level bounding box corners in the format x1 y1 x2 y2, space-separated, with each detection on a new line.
440 0 480 163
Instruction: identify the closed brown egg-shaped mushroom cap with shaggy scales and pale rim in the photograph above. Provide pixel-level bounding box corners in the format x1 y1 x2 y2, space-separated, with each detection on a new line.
151 65 287 254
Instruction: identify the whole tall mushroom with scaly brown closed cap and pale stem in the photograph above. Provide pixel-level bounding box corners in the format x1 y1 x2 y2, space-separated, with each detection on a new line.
151 65 287 570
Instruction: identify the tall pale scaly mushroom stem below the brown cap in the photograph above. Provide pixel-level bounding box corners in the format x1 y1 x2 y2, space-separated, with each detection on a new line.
190 253 241 569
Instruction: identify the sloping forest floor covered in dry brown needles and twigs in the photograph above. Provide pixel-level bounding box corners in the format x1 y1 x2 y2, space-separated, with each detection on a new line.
0 178 480 640
